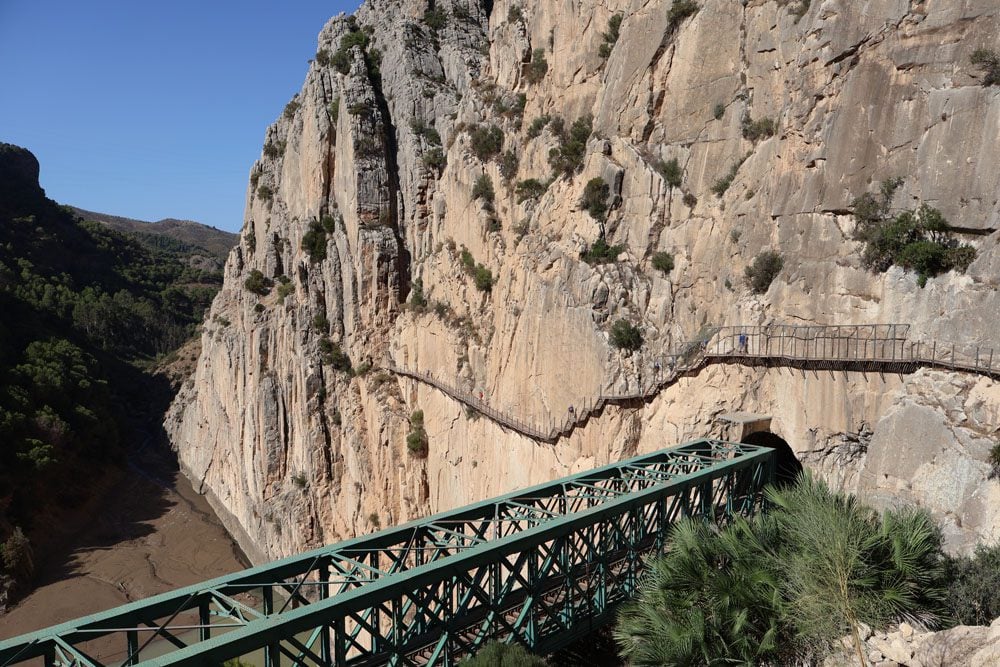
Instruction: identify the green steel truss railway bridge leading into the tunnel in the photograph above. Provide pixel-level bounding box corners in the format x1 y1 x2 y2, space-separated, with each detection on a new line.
0 439 774 667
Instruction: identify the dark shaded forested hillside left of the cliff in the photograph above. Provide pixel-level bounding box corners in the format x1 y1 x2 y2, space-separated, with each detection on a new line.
0 144 227 596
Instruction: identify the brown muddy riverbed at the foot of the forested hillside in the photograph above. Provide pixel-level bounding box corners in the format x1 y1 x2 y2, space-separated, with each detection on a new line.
0 454 247 640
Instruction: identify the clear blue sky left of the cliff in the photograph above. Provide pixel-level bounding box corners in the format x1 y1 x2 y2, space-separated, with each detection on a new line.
0 0 359 231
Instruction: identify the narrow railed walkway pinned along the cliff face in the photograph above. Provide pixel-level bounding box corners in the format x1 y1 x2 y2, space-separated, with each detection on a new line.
387 324 1000 443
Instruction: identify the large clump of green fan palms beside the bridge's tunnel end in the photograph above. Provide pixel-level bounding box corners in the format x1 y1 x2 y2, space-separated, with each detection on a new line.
616 476 947 665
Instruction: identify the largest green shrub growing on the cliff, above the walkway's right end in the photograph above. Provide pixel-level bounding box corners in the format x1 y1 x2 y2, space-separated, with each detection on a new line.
853 178 976 287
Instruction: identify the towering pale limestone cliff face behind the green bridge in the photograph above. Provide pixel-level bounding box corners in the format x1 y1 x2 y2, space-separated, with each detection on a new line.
167 0 1000 559
